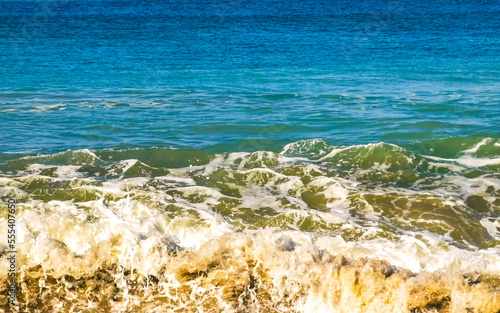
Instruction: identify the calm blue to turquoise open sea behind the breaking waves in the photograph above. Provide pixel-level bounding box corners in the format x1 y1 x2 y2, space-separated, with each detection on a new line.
0 0 500 152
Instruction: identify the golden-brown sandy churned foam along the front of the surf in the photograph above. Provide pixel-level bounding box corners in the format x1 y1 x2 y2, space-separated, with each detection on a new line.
0 230 500 313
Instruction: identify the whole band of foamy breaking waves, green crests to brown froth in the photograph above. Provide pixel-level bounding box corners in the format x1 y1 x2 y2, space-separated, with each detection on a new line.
0 138 500 313
